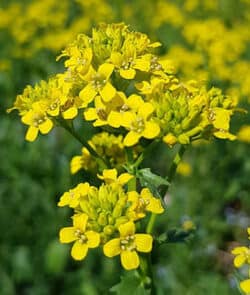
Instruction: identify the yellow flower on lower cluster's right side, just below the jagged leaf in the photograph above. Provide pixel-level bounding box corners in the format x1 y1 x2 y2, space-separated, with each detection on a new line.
128 188 164 220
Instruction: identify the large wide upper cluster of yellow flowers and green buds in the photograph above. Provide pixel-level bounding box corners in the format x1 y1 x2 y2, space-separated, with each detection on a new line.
9 23 236 149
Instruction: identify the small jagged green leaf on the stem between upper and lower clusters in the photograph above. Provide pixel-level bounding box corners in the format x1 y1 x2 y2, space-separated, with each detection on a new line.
137 168 170 198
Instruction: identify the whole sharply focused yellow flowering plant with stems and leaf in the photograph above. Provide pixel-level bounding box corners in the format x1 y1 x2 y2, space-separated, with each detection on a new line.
10 23 241 294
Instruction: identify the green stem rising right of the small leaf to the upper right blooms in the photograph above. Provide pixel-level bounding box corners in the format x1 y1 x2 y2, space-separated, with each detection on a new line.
146 145 185 234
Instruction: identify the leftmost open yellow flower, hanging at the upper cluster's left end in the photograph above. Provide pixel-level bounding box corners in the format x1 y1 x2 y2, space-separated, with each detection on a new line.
22 103 53 141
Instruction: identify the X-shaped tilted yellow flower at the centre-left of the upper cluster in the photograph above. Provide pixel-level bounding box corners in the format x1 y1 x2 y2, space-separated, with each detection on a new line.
79 63 116 106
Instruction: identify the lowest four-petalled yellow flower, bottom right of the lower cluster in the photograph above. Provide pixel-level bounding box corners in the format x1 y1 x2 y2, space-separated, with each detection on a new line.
103 222 153 270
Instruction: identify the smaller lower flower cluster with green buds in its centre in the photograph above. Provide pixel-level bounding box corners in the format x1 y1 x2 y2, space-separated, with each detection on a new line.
58 169 164 270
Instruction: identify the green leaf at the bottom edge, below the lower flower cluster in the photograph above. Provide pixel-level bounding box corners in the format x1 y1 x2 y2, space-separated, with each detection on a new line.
110 271 150 295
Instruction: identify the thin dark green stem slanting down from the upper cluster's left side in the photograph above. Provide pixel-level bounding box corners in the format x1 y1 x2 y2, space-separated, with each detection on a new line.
59 120 108 170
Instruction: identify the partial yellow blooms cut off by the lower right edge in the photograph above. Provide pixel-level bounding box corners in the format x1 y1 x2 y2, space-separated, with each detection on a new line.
232 227 250 294
